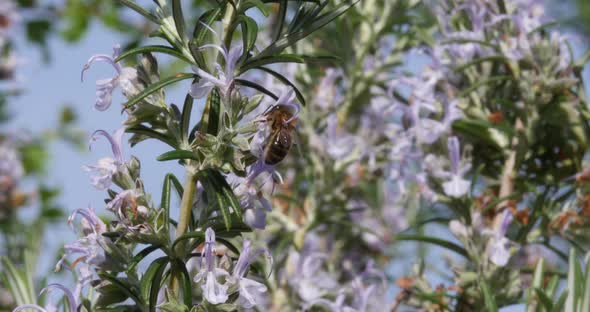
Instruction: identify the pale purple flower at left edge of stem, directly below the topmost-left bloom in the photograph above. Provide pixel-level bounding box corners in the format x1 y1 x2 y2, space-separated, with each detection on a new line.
83 128 125 190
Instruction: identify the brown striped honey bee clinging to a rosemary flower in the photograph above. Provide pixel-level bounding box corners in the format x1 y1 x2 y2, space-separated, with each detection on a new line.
262 104 298 166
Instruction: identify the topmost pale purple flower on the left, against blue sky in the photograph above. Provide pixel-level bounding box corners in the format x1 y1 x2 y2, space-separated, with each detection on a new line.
82 45 140 111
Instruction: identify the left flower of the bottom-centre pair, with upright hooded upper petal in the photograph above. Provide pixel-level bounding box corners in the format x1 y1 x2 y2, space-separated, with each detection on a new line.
194 228 230 304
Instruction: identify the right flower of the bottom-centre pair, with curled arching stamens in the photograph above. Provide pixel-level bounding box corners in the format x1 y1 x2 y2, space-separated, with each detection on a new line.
231 240 272 309
